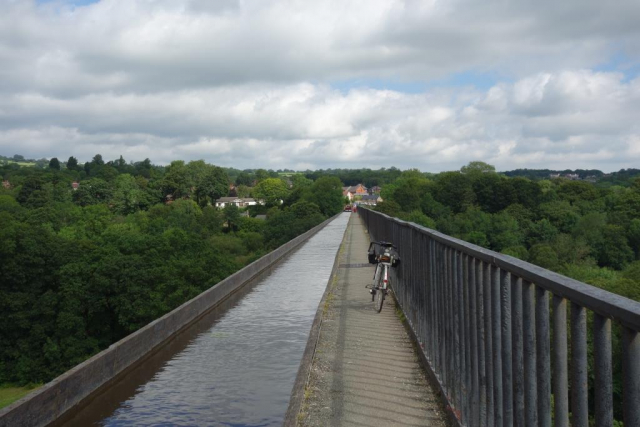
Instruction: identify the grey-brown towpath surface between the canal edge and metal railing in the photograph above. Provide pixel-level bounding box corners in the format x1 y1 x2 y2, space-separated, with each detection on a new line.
298 214 446 427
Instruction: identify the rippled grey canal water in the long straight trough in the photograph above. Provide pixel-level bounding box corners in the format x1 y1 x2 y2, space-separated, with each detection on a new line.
57 213 349 427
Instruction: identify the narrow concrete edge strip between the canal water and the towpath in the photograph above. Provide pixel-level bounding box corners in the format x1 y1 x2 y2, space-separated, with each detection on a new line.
282 212 348 427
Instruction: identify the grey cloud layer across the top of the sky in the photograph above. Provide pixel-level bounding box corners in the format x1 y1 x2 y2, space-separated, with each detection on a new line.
0 0 640 96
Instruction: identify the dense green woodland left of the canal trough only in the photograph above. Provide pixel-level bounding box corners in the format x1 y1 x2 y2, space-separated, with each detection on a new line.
0 155 343 385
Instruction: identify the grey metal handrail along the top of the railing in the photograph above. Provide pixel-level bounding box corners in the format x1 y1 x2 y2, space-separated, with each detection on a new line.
369 209 640 331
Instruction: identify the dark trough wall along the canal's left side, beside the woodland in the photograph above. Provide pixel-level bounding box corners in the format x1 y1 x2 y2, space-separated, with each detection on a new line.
0 215 337 427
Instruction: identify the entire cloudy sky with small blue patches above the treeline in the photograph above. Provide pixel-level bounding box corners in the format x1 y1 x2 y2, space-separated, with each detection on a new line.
0 0 640 172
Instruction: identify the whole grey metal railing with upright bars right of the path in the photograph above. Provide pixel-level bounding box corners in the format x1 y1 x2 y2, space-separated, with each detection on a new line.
358 209 640 427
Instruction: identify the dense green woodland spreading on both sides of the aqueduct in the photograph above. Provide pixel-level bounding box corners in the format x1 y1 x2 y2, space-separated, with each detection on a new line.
0 155 640 422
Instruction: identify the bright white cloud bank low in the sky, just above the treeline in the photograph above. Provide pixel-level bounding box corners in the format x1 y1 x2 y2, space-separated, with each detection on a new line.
0 70 640 171
